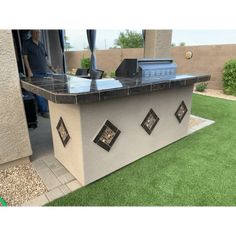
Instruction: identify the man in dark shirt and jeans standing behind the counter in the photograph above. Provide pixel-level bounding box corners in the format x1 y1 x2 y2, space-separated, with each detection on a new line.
23 30 56 118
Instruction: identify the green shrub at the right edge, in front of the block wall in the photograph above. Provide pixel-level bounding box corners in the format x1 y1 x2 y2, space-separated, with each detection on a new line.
223 59 236 96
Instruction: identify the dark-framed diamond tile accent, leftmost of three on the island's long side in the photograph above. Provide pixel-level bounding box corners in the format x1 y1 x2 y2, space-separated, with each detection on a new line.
93 120 120 152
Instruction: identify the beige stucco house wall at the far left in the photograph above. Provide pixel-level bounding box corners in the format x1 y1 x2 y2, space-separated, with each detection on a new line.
0 30 32 166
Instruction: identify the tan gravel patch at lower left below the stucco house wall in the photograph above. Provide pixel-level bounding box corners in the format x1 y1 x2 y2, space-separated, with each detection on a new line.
0 163 47 206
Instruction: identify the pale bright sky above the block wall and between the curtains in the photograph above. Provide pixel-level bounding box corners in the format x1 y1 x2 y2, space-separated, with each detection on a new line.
66 29 236 50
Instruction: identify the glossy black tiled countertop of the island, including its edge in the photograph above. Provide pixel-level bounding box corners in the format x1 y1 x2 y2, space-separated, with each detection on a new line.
21 74 211 104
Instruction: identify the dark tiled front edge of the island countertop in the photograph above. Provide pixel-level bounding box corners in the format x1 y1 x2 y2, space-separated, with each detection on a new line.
21 74 211 104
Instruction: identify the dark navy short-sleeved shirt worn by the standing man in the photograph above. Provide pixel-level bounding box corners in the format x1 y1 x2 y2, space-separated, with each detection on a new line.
23 39 49 74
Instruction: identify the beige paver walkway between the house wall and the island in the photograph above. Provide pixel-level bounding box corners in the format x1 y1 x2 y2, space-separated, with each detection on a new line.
23 116 81 206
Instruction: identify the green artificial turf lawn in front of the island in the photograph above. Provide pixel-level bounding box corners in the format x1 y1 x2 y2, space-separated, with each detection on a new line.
48 95 236 206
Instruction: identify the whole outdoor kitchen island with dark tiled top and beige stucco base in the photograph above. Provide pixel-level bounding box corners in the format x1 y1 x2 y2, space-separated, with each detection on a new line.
21 71 210 185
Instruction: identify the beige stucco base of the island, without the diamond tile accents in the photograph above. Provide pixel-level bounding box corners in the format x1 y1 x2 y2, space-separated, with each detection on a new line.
49 86 193 185
